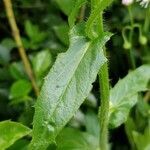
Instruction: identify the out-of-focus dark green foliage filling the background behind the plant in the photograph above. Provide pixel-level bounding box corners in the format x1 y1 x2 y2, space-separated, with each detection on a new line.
0 0 150 150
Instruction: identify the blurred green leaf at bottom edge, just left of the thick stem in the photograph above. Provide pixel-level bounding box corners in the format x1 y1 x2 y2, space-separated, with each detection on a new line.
56 128 99 150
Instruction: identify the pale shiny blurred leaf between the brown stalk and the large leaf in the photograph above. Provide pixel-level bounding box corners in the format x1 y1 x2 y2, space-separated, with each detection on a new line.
33 50 52 78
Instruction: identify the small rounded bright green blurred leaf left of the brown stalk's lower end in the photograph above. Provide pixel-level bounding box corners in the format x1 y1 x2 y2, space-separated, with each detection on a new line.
10 80 32 99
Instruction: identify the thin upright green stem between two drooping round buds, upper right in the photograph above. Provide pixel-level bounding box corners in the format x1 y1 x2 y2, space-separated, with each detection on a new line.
128 6 136 69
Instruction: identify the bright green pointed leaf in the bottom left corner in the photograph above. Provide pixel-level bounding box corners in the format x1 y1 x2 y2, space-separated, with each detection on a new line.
0 121 31 150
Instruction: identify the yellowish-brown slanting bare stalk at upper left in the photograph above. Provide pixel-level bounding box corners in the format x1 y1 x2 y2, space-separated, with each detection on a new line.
3 0 39 96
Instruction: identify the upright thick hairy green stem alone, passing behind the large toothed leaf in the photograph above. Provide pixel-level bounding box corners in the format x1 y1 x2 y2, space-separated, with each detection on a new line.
98 13 109 150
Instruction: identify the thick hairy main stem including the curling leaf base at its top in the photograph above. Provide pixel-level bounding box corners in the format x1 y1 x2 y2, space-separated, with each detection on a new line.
86 0 113 150
